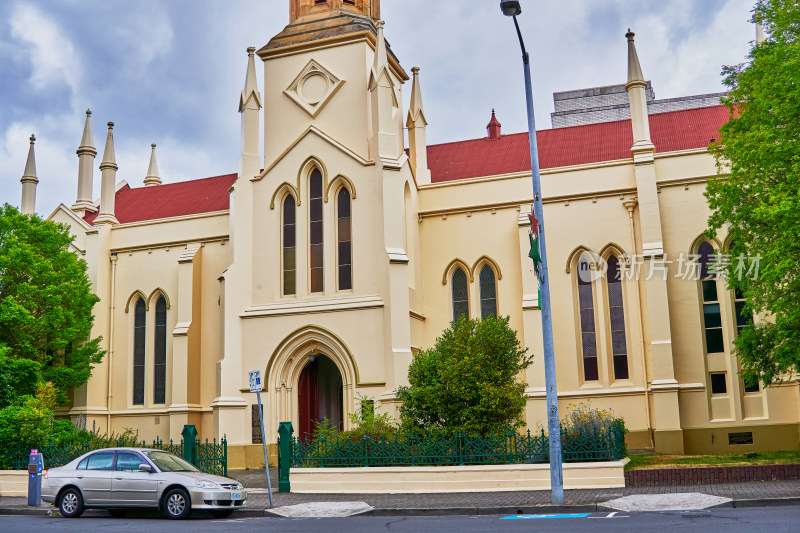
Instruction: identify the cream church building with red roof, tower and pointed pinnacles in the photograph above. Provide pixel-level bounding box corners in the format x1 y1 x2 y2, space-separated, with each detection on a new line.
22 0 800 468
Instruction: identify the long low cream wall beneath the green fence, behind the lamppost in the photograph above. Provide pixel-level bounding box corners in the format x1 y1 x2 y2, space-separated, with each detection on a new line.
289 459 628 494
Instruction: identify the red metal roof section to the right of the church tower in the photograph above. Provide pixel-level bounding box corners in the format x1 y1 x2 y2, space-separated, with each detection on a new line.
428 106 730 183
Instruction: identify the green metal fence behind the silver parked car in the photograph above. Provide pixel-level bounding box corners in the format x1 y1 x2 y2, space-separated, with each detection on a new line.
0 426 228 476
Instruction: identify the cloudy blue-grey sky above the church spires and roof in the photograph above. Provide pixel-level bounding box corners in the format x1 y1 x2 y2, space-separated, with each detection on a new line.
0 0 755 216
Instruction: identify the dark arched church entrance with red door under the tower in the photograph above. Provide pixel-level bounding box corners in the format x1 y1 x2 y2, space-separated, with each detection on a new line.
297 354 344 440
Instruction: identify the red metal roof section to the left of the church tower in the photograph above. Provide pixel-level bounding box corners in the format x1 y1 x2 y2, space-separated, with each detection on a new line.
84 174 236 224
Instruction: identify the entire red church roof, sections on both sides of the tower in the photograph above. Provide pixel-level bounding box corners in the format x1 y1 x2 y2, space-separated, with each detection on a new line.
84 106 730 224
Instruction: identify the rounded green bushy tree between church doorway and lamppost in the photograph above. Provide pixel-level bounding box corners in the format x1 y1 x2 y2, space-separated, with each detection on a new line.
397 317 532 435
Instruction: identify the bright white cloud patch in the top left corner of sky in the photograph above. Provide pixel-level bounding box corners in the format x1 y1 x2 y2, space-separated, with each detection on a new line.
9 3 82 97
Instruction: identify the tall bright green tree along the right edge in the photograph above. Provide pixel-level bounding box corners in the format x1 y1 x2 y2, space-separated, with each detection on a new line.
706 0 800 385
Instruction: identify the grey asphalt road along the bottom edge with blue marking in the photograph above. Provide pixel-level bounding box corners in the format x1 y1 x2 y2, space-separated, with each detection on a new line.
0 506 800 533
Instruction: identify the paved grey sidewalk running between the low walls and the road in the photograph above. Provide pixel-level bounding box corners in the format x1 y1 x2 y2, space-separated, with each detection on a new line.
0 469 800 515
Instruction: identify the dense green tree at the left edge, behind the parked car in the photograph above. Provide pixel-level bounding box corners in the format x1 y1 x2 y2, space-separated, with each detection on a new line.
0 205 104 407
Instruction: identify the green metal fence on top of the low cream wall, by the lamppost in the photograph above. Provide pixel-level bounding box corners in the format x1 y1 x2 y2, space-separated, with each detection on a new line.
278 424 626 468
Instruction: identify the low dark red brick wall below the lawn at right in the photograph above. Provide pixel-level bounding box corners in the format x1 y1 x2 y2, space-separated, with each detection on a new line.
625 464 800 487
